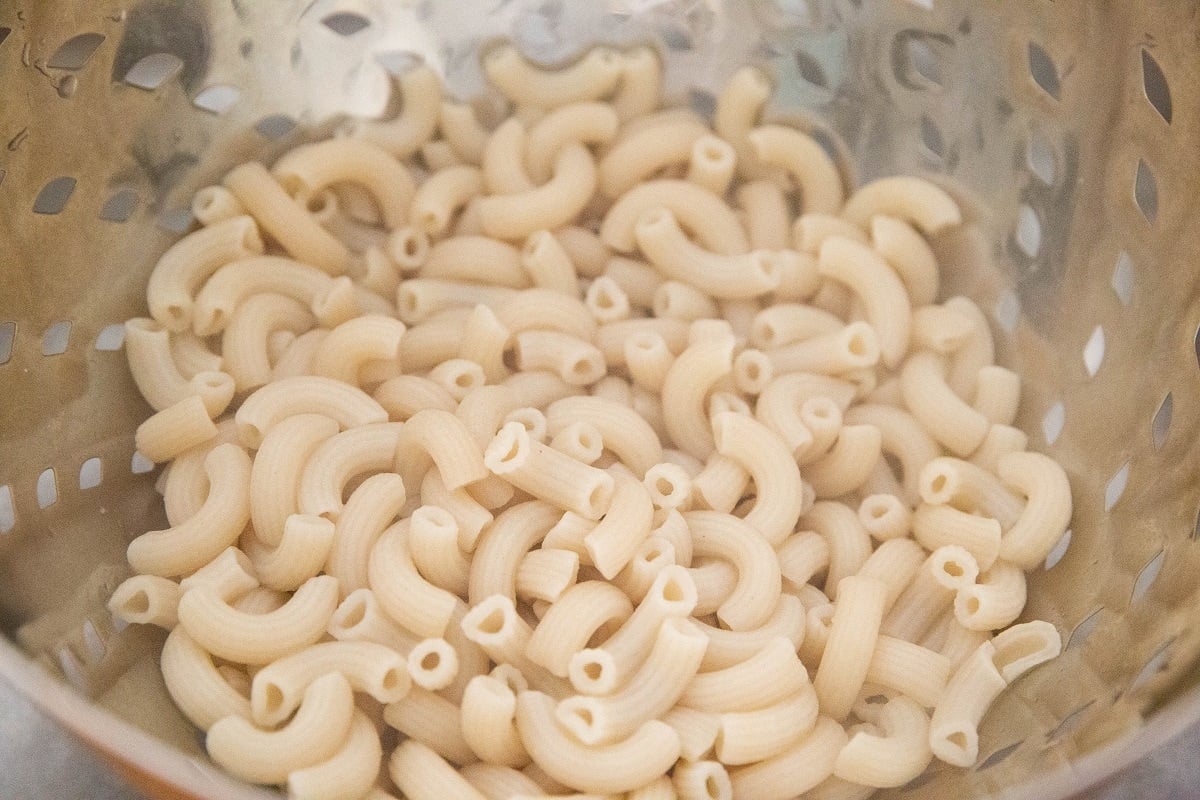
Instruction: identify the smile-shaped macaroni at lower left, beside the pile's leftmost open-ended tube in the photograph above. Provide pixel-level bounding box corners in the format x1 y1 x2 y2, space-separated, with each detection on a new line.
179 576 337 664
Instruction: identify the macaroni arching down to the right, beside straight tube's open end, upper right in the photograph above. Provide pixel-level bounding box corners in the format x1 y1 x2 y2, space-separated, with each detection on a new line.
817 236 912 367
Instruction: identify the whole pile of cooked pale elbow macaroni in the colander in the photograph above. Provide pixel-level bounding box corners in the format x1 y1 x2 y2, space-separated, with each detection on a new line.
110 46 1072 800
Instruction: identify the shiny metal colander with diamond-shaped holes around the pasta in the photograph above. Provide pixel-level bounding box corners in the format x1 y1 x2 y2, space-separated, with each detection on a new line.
0 0 1200 799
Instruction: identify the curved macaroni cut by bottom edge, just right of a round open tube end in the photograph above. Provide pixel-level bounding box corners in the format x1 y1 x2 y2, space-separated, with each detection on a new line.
730 715 848 800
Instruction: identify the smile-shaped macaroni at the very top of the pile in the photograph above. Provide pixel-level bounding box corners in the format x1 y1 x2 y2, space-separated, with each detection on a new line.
482 44 624 109
